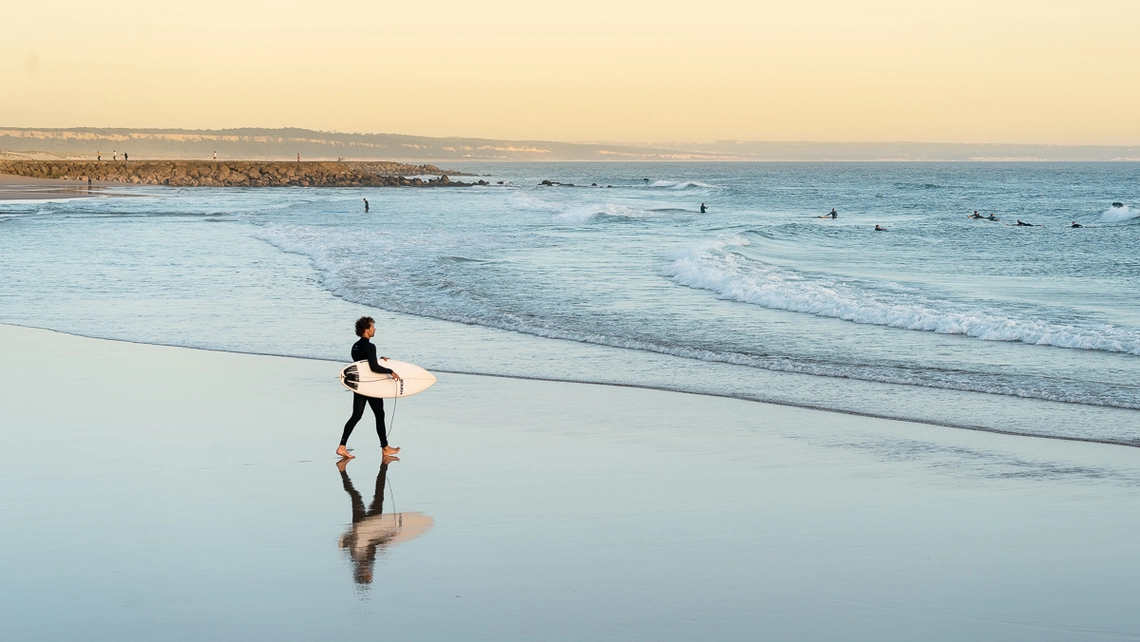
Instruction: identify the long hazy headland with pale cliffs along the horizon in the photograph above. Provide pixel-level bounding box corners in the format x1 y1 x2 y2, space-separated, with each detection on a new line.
0 127 1140 163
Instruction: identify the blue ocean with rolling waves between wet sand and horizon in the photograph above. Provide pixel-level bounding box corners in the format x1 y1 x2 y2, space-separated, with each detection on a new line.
0 162 1140 445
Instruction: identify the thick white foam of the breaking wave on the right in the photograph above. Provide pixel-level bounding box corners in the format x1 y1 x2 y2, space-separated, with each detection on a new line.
665 236 1140 356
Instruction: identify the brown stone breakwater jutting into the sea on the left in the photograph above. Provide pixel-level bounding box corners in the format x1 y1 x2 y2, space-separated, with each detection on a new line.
0 161 486 187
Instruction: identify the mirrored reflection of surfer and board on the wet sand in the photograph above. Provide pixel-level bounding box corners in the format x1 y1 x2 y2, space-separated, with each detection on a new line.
336 457 434 584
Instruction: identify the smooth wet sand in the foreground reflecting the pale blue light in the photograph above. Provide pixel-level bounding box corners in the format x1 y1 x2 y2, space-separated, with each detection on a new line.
0 326 1140 641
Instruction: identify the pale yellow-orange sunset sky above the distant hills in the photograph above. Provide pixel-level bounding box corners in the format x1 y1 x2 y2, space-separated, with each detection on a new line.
0 0 1140 145
